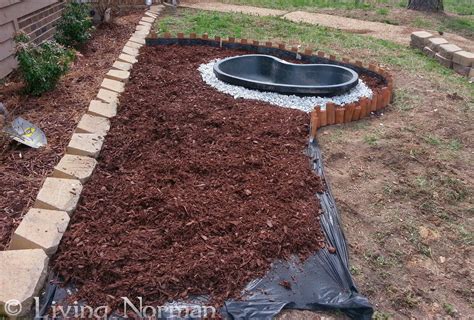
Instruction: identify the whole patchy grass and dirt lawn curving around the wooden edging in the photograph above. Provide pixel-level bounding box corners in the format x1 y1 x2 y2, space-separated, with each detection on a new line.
156 7 474 319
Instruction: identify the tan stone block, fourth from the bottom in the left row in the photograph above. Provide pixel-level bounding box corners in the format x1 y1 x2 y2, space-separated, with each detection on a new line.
53 154 97 184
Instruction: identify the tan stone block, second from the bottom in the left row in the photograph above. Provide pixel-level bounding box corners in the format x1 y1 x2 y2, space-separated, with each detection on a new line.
8 209 70 257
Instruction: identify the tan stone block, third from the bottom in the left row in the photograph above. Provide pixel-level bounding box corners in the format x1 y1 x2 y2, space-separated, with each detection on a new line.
34 177 82 214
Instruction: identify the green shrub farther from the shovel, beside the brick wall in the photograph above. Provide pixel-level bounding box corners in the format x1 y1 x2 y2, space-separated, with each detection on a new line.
55 2 94 48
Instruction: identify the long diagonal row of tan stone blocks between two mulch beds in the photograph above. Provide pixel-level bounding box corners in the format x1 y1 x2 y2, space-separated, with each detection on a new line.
0 5 162 316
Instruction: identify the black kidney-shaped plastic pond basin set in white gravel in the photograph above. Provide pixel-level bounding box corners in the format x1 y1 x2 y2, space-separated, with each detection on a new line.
214 54 359 96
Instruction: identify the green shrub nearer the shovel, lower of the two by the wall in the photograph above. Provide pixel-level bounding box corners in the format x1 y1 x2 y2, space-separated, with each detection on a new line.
15 34 75 95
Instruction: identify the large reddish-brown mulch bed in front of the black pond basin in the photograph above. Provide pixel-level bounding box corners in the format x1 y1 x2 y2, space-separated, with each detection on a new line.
53 46 325 307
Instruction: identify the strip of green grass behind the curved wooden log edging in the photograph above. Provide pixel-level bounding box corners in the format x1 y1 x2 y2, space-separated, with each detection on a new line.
156 9 474 99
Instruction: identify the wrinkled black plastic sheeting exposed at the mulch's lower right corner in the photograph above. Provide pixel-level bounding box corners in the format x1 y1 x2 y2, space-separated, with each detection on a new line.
224 140 373 319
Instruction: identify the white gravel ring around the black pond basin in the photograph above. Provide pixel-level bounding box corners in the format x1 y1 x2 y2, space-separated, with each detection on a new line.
198 59 372 112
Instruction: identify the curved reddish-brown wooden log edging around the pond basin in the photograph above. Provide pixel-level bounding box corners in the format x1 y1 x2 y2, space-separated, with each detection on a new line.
145 32 393 140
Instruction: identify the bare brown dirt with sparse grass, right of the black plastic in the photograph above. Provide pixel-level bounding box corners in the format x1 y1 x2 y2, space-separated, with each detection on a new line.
319 67 474 318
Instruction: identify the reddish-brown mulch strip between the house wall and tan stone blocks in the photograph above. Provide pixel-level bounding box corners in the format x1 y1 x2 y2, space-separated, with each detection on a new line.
0 12 142 250
